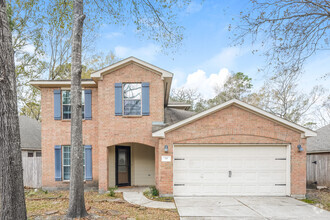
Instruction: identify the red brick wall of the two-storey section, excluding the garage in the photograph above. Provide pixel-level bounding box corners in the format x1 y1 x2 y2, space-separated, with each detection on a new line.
41 64 164 191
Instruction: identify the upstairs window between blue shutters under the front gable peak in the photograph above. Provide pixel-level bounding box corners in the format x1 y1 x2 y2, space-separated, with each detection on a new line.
123 83 142 115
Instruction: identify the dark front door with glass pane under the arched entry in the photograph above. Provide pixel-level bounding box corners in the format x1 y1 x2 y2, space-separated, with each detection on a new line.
116 146 131 186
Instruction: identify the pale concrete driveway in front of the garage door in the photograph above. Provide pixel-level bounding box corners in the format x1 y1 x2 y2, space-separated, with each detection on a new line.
174 197 330 220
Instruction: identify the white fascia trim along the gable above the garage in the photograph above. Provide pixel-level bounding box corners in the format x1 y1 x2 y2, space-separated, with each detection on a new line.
152 99 317 138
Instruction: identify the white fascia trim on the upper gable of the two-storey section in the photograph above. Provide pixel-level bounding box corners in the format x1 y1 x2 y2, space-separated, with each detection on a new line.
91 57 173 79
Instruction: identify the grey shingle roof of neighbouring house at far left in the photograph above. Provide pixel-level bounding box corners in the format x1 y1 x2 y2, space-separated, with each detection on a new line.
19 115 41 150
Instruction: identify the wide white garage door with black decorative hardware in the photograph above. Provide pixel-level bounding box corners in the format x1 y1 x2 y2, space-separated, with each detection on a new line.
173 145 290 196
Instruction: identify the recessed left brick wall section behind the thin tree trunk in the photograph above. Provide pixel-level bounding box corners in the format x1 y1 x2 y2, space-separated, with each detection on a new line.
41 88 98 188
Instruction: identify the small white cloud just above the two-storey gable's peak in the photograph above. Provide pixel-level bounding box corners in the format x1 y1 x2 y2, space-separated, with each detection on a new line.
115 44 159 62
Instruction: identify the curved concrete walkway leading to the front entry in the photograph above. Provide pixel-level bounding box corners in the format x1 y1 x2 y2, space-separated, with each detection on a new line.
116 187 176 209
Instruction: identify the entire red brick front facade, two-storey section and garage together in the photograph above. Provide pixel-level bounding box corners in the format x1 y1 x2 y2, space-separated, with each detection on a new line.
41 64 306 195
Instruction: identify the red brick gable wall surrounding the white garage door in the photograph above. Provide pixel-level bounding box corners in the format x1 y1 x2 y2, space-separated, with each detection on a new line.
156 106 306 195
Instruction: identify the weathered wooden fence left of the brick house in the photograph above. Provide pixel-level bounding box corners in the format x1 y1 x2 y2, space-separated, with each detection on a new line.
22 157 41 188
